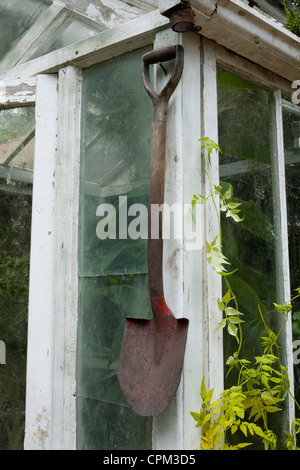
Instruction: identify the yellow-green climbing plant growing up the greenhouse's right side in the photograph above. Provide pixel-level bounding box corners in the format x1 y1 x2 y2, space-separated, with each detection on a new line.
191 137 300 450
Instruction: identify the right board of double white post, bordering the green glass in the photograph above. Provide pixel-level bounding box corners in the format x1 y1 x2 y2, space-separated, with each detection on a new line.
52 66 82 450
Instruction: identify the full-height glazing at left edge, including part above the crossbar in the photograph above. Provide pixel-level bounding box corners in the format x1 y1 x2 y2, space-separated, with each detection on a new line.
0 107 35 450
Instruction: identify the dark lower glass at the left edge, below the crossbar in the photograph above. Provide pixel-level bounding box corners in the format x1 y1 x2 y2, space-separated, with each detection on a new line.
0 184 31 450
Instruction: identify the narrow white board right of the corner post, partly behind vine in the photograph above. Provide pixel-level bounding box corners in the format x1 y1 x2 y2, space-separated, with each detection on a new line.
197 38 223 396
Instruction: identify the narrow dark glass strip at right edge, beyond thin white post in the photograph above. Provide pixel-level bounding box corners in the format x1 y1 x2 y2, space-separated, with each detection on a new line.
283 98 300 418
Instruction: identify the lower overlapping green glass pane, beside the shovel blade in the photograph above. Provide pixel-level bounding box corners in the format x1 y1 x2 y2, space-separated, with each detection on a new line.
77 275 151 449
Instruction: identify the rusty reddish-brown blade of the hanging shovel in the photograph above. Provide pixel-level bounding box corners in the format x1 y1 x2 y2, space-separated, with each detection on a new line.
118 298 188 416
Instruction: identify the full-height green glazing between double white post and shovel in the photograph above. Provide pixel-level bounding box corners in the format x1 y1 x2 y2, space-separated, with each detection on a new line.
77 49 152 449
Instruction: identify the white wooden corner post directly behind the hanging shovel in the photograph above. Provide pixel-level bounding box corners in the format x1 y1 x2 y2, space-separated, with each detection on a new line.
153 30 203 450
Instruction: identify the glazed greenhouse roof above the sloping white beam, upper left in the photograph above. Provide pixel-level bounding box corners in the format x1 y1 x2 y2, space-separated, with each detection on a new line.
0 0 156 73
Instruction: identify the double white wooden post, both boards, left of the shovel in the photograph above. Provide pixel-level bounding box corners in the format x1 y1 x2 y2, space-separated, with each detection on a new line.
25 66 81 450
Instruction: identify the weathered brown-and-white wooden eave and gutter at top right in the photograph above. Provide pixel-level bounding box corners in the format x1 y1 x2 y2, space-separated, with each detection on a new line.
191 0 300 81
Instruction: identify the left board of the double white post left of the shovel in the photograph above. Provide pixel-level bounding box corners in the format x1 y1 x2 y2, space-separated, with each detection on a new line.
24 75 58 450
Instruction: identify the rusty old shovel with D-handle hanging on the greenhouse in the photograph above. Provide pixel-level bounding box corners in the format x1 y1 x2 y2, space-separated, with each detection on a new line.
118 45 188 416
